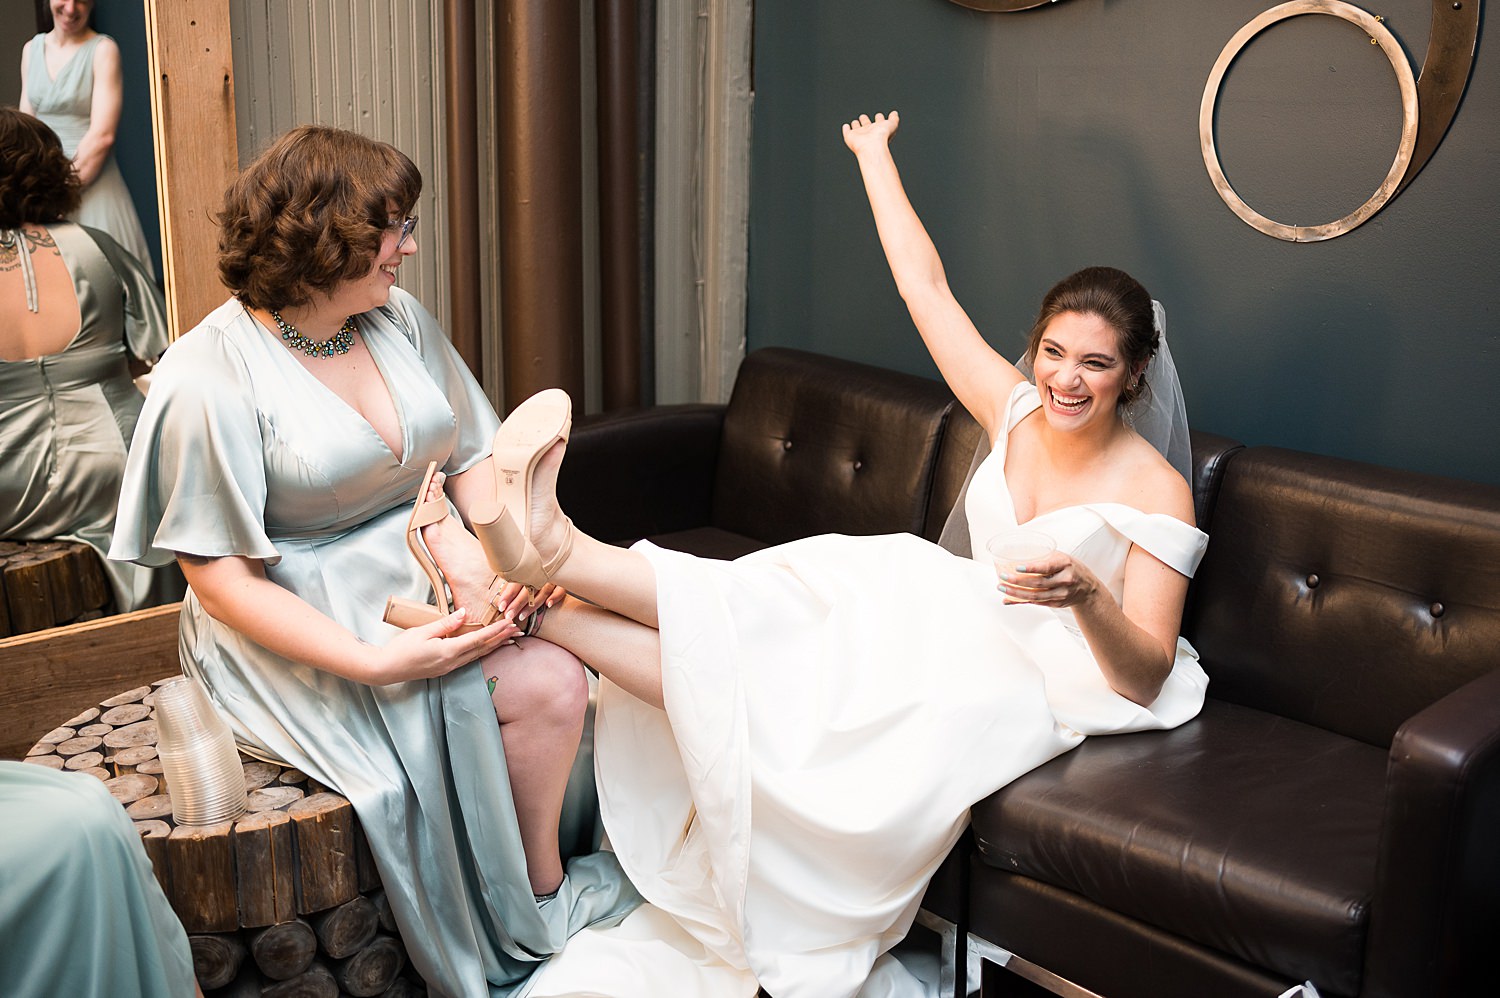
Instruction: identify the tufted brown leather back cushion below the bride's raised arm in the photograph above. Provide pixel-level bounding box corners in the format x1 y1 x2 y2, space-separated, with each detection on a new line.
711 348 954 543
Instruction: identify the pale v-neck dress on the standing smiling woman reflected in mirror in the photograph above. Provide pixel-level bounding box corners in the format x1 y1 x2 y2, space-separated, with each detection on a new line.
26 35 156 278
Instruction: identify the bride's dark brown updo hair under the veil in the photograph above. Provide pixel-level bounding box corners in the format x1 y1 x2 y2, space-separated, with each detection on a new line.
1026 267 1161 405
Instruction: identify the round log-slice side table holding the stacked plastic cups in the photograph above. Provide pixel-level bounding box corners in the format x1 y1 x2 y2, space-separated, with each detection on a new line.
26 678 426 998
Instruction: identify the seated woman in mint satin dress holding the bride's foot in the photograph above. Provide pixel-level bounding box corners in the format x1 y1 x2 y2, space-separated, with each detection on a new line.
111 126 638 996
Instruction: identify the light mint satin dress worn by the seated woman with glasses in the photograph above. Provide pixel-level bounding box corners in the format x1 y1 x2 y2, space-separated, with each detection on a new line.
111 288 638 996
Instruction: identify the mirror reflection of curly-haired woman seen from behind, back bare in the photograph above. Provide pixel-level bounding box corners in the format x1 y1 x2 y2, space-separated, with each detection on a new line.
0 108 183 611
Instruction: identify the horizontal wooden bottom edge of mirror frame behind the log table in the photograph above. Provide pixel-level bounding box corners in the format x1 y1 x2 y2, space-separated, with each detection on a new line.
0 603 182 759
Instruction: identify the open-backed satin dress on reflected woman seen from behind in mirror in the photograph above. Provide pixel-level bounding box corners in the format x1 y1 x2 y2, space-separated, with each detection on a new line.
0 222 185 611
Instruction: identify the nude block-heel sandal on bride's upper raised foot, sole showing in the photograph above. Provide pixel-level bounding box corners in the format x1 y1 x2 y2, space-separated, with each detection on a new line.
470 389 573 588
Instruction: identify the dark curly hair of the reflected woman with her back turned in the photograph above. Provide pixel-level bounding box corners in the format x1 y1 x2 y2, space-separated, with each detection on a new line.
0 108 83 228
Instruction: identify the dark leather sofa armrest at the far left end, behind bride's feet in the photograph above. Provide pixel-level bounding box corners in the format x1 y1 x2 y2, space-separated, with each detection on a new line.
558 404 725 542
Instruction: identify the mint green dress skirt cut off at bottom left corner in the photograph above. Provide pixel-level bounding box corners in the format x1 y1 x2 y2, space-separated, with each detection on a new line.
0 761 194 998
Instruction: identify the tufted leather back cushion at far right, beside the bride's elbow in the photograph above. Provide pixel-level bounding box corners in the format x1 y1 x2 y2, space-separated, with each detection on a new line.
1184 447 1500 747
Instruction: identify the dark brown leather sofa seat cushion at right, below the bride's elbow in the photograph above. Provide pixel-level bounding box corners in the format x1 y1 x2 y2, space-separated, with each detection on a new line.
974 699 1386 993
